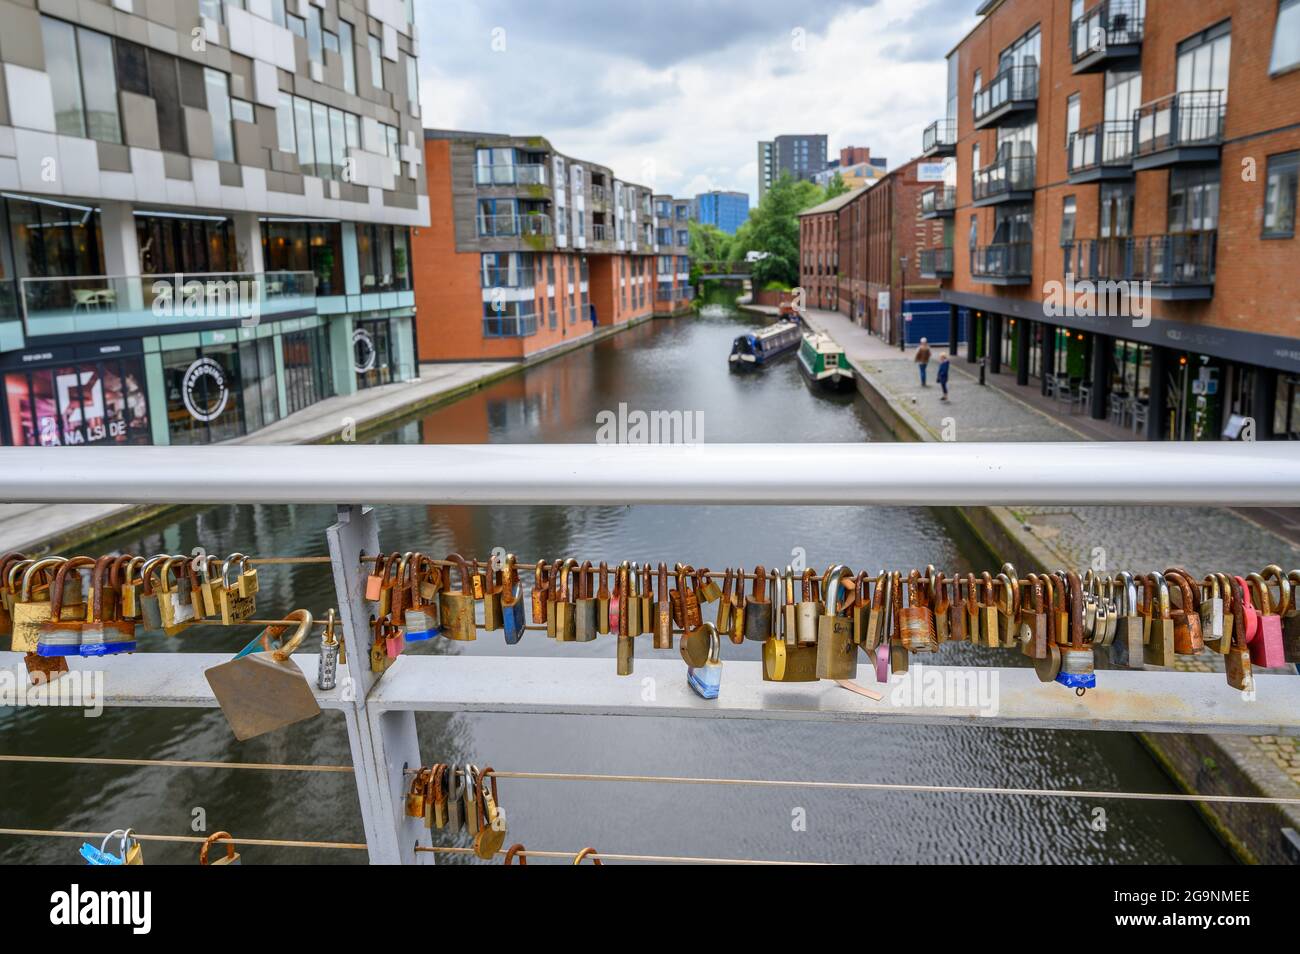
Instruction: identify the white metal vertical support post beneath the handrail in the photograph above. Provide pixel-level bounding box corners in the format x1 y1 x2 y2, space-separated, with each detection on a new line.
326 504 433 864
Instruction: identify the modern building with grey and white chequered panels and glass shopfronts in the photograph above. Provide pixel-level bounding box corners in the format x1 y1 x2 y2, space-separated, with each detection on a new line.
0 0 429 446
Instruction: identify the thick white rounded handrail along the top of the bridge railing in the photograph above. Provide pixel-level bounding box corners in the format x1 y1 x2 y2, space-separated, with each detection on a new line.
0 447 1300 507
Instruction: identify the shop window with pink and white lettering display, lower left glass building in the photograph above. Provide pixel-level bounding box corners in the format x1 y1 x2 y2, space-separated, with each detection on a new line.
5 357 152 447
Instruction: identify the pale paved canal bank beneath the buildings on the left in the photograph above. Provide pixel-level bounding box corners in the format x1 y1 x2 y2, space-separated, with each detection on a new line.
0 316 653 554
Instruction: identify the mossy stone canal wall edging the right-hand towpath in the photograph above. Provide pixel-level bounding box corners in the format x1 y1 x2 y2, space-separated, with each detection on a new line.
854 348 1300 864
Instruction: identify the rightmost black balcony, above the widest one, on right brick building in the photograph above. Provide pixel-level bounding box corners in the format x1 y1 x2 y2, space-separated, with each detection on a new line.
1134 90 1227 172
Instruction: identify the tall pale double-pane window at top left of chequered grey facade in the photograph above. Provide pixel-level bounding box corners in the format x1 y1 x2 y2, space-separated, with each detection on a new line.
40 17 122 143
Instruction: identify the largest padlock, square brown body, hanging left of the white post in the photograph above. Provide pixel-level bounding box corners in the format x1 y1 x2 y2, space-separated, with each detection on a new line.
204 610 321 742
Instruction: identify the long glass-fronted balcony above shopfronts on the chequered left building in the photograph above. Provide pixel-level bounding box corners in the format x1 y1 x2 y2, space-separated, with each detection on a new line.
19 272 316 343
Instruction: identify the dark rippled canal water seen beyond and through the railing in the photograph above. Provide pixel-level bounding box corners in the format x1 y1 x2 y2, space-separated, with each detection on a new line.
0 289 1231 864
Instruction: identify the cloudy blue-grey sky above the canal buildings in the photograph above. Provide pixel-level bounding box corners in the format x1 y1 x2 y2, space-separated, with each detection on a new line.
416 0 978 201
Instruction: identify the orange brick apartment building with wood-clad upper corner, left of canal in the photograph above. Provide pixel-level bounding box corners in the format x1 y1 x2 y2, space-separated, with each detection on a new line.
412 130 690 361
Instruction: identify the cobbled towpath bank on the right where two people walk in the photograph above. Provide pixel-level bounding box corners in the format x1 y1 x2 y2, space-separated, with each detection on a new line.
769 302 1300 864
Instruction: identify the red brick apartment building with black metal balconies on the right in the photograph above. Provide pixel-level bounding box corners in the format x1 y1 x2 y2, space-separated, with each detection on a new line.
922 0 1300 439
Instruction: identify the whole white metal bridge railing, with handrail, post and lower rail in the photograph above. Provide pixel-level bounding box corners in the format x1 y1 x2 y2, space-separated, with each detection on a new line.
0 443 1300 863
